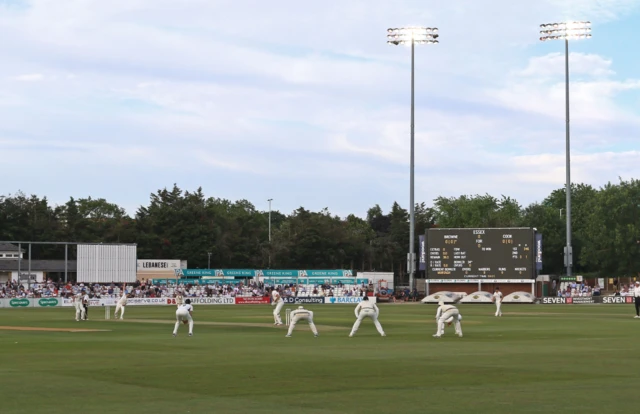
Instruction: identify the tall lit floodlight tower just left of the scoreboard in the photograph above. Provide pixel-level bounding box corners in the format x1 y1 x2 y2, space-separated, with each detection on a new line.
387 26 439 291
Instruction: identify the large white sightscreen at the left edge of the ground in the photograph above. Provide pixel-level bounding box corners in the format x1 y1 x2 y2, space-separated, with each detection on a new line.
78 244 137 283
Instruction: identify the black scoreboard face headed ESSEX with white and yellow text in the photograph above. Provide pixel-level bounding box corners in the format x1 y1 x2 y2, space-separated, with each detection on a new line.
427 227 535 279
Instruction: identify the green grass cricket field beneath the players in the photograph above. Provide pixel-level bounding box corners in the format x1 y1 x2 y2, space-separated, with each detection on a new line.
0 304 640 414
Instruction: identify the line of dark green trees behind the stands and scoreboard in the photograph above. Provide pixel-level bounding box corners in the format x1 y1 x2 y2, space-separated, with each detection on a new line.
0 179 640 276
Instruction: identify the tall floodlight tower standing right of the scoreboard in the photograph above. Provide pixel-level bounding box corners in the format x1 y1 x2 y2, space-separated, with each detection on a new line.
540 21 591 276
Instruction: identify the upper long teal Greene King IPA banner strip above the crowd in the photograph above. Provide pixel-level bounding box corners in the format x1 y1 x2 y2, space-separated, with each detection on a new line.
174 269 353 278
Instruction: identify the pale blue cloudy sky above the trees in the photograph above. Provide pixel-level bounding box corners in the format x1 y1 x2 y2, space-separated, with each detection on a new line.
0 0 640 216
